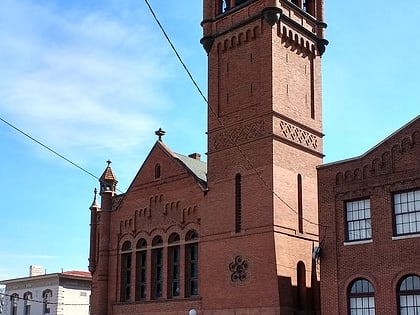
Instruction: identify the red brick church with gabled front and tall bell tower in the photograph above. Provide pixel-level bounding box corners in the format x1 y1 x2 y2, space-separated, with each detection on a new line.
89 0 327 315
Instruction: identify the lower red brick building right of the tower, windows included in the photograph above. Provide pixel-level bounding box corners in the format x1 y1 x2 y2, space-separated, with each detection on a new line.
318 116 420 315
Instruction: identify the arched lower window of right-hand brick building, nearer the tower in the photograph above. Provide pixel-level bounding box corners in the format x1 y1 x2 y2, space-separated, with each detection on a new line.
349 279 375 315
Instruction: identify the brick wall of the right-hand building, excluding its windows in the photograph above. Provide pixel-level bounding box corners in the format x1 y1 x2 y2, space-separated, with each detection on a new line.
318 118 420 315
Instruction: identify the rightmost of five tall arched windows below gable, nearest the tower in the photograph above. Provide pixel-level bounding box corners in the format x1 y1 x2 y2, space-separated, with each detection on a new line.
185 230 198 296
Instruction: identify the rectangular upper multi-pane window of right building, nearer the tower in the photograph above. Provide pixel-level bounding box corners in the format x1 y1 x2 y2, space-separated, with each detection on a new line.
346 199 372 241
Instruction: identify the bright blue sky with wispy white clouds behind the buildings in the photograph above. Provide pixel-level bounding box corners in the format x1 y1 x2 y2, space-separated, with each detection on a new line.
0 0 420 280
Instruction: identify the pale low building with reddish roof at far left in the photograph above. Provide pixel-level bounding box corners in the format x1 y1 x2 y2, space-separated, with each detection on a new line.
0 270 92 315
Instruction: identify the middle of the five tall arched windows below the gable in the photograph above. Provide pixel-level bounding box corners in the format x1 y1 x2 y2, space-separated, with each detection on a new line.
152 236 163 299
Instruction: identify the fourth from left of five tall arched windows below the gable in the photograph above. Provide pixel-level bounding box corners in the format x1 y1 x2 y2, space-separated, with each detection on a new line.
168 233 181 297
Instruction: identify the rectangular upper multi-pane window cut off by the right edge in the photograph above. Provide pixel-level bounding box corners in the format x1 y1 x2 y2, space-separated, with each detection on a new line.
394 190 420 235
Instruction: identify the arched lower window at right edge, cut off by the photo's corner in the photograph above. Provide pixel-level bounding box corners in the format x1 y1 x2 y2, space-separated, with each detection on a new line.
398 275 420 315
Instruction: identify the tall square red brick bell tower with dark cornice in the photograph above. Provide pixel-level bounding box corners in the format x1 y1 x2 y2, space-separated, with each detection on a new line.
200 0 328 315
